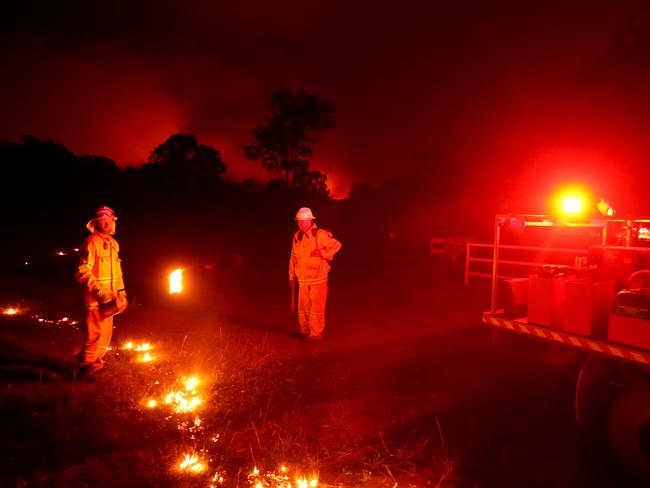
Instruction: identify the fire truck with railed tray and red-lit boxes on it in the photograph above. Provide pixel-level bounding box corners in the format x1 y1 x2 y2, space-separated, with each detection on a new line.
478 207 650 480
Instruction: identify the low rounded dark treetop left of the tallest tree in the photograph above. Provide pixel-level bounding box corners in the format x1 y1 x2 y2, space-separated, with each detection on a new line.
147 134 227 182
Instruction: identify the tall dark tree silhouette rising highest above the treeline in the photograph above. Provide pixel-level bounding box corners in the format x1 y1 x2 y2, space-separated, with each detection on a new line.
244 89 335 188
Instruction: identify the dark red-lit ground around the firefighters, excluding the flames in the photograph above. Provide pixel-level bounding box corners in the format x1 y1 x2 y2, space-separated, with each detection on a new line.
0 255 641 487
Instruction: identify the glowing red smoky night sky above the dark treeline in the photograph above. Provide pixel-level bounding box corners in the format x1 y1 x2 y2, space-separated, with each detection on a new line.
0 0 650 206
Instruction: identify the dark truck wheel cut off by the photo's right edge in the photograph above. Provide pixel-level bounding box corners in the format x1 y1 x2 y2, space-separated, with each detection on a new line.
607 385 650 480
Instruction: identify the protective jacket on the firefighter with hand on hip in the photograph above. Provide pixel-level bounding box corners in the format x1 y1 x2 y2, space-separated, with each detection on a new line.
289 225 341 285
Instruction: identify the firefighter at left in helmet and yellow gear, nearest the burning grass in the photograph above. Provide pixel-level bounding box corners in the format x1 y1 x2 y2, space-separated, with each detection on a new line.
77 207 128 374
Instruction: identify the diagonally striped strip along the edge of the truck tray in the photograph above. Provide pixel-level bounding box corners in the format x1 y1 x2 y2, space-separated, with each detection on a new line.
483 311 650 367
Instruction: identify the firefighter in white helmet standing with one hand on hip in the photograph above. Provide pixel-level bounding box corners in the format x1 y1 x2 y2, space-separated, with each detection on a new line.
289 207 341 339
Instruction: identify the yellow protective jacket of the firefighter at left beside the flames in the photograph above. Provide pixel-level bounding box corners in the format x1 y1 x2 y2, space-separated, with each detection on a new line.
77 232 124 305
